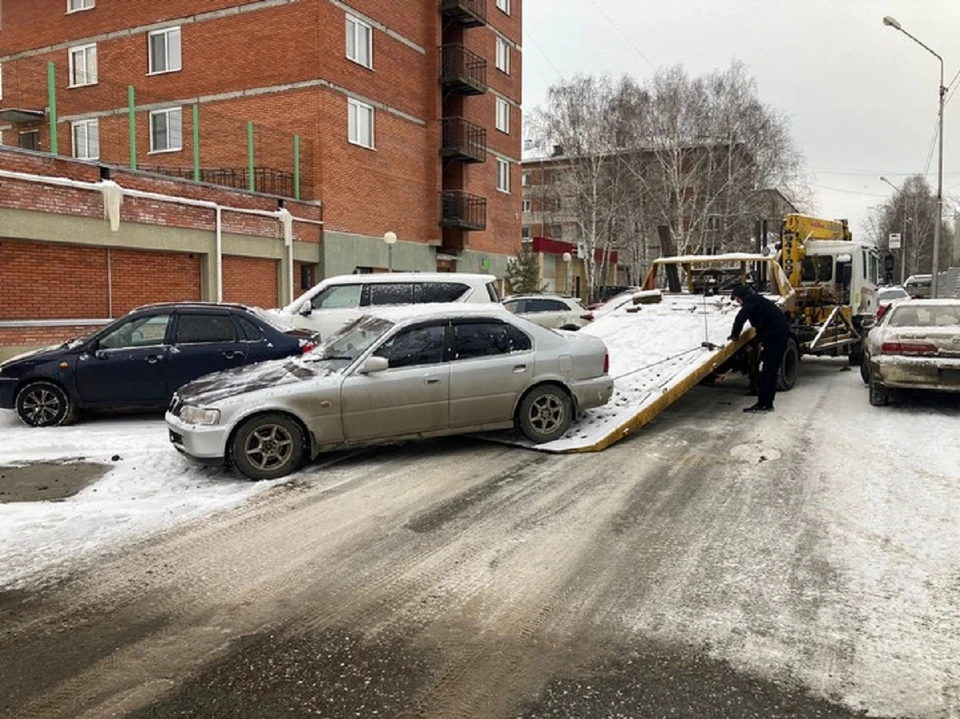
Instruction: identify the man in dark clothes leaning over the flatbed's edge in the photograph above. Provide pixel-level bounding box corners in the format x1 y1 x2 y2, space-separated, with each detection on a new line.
730 285 790 412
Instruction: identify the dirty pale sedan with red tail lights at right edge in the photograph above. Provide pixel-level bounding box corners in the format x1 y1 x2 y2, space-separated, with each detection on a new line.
861 300 960 407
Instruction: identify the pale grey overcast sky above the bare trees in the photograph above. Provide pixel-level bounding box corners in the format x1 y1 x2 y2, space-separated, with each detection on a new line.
523 0 960 242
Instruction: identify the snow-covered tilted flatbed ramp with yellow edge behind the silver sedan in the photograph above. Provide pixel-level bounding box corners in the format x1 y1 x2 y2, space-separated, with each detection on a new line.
485 295 753 452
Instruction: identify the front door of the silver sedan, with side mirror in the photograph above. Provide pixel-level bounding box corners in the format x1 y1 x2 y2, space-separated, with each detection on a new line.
340 320 450 442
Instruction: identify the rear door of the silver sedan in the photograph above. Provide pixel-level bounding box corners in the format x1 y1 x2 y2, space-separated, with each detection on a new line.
450 319 534 428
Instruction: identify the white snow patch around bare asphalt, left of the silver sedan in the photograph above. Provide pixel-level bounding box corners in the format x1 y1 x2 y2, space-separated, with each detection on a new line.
0 411 275 590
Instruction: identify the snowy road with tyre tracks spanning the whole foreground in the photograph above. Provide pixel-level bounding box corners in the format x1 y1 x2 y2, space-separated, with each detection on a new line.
0 361 960 719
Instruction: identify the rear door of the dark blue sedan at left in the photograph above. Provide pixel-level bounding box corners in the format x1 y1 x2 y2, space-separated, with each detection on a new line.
167 310 247 395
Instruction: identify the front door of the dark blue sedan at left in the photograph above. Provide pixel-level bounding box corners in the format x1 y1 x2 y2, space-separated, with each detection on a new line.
76 312 172 406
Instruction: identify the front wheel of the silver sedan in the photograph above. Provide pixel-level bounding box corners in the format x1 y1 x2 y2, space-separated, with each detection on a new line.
230 414 304 479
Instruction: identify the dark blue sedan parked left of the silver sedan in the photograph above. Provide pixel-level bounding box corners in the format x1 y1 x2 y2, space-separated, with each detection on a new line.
0 302 315 427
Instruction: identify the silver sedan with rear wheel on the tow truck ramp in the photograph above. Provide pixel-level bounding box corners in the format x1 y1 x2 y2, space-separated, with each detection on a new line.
167 305 613 479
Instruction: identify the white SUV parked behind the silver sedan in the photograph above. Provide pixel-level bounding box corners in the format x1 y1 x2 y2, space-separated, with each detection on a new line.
270 272 500 339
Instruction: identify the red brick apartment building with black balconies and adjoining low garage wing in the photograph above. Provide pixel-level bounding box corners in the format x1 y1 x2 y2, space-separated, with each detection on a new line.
0 0 522 354
